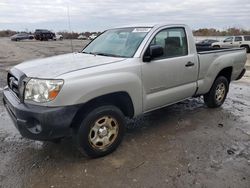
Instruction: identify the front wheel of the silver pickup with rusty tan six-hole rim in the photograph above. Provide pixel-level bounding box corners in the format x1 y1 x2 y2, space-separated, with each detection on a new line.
76 105 125 158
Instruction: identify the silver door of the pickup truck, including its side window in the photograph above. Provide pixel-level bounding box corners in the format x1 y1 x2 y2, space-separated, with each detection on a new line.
142 27 198 111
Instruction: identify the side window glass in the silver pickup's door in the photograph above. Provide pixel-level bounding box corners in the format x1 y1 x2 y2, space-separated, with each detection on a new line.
150 28 188 59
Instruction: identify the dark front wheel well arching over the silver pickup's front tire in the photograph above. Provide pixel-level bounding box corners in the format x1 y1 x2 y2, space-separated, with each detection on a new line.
71 92 134 127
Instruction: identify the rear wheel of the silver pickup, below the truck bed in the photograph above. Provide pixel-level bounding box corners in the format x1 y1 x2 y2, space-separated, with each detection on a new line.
203 76 229 108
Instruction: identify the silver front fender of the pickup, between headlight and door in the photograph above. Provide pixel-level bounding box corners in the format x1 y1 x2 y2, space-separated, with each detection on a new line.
50 72 142 115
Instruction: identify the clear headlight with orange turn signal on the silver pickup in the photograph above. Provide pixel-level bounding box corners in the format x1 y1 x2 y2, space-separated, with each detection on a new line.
24 78 63 103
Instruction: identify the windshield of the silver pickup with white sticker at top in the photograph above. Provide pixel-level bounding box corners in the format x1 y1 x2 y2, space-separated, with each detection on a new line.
82 27 151 57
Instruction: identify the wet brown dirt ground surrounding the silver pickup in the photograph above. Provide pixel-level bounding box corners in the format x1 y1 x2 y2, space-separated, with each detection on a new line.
0 38 250 188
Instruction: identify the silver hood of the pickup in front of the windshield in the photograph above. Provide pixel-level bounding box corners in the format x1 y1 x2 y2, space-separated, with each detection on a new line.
15 53 125 78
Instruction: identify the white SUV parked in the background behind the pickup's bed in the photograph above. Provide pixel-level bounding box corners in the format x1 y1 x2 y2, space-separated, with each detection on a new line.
212 35 250 53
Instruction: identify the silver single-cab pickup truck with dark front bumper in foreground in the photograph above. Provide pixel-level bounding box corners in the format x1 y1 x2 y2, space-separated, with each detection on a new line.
3 25 247 157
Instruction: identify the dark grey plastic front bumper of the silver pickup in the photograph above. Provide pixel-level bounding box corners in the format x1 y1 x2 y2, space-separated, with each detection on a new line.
3 87 79 141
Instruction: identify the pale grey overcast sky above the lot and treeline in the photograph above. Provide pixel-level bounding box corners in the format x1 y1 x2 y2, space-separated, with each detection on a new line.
0 0 250 32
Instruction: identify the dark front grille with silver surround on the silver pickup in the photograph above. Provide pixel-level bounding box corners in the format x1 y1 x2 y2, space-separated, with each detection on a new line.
7 68 26 101
